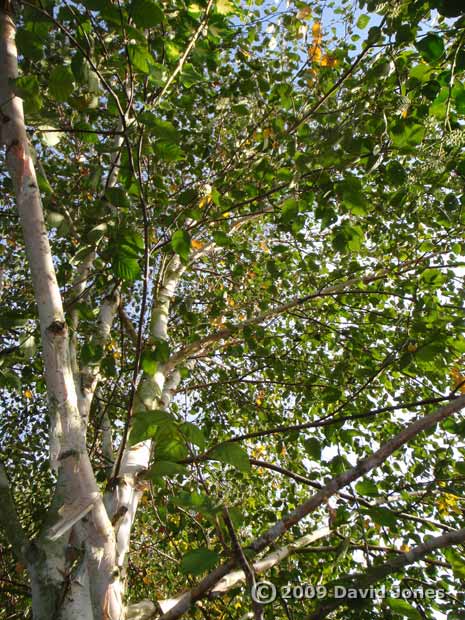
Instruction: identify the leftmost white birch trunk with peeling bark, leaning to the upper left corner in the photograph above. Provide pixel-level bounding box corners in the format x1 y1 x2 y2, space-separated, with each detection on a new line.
0 11 118 620
